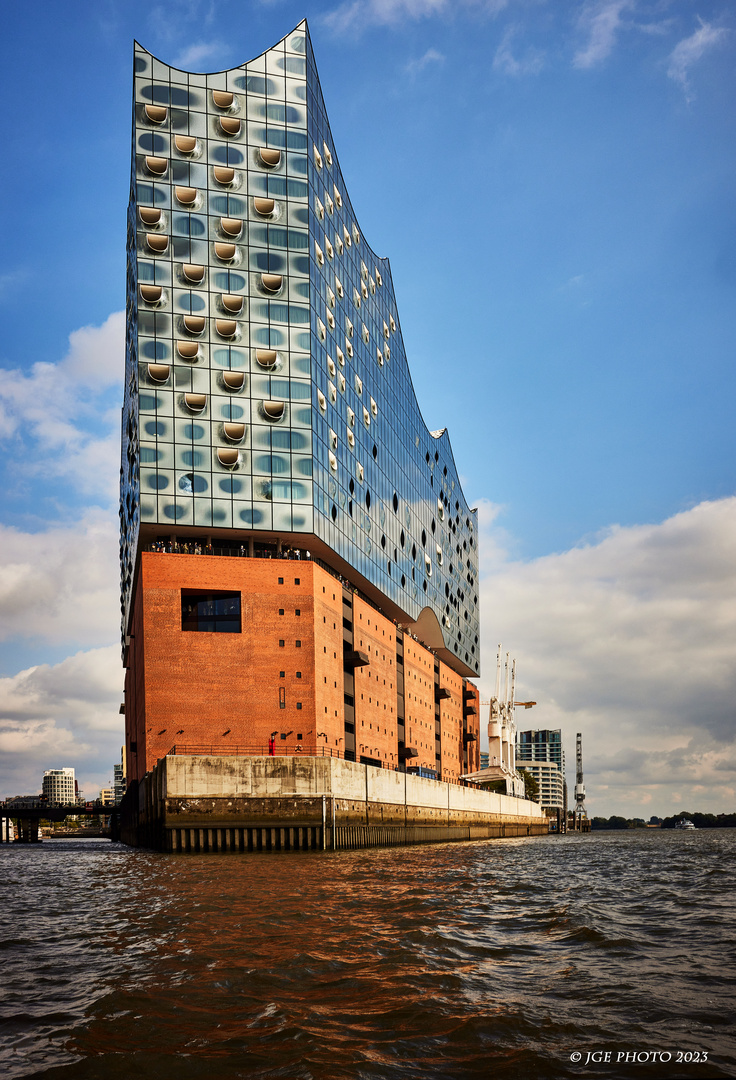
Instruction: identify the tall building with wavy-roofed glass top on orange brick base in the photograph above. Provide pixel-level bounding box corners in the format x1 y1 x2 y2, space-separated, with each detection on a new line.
120 23 480 784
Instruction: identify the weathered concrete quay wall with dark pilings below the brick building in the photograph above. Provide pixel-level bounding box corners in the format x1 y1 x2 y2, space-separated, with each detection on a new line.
120 755 548 854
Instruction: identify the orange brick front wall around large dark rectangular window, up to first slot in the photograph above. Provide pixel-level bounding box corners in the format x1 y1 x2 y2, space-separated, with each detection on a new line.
126 552 344 779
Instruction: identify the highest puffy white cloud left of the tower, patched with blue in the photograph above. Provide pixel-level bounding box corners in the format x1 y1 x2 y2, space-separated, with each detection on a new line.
0 311 125 499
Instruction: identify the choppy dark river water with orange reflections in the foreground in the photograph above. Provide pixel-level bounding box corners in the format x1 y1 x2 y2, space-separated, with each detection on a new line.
0 829 736 1080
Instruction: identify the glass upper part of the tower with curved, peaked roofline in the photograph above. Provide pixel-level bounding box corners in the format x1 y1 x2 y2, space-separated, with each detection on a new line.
121 23 480 676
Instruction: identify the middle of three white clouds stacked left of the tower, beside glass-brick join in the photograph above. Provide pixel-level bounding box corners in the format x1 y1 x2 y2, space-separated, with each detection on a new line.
0 510 120 647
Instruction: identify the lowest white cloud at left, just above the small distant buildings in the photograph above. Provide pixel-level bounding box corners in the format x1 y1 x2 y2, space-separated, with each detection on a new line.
0 645 123 798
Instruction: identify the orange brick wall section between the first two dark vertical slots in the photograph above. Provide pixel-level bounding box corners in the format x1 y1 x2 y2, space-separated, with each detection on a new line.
352 593 399 768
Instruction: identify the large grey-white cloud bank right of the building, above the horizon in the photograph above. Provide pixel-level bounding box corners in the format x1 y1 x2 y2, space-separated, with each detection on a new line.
481 498 736 816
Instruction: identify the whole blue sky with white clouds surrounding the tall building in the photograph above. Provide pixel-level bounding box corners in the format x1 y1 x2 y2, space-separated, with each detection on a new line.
0 0 736 815
